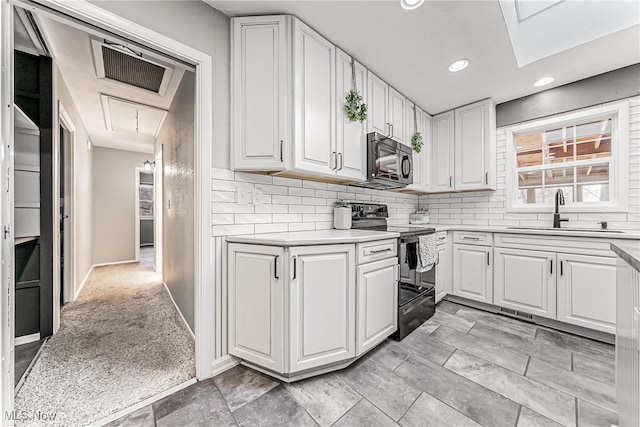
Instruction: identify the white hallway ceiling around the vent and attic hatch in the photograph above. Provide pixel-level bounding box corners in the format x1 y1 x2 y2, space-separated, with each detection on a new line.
38 16 184 153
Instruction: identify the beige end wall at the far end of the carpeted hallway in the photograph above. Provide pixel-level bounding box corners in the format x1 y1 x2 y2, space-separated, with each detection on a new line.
91 147 153 264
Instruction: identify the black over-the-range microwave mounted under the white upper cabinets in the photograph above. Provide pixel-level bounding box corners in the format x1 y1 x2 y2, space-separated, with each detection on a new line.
351 132 413 190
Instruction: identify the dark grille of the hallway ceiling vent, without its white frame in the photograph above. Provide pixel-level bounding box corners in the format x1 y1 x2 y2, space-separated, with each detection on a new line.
102 46 165 93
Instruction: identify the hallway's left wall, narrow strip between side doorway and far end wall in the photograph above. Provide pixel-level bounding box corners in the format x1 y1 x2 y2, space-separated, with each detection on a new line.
54 67 93 296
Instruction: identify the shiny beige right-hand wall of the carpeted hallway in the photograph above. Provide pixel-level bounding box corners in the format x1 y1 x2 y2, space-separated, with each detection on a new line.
156 72 195 330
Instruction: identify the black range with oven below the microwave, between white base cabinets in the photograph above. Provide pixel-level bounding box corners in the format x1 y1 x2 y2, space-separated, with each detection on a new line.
351 203 436 341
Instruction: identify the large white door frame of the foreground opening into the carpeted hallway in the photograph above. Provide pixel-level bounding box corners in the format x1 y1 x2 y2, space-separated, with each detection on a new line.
0 0 216 413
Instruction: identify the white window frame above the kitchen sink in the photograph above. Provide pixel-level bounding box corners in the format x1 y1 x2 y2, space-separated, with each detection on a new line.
505 101 629 213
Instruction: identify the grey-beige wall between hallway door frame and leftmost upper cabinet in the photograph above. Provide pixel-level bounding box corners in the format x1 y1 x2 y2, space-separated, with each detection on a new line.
90 0 231 168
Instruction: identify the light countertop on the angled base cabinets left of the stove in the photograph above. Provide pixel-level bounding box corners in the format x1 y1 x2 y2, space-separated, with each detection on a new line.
226 230 400 246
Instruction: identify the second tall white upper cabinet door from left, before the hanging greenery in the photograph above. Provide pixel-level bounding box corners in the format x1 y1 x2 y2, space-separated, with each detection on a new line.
293 19 336 174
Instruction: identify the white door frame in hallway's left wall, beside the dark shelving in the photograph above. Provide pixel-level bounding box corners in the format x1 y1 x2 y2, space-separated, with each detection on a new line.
53 101 77 314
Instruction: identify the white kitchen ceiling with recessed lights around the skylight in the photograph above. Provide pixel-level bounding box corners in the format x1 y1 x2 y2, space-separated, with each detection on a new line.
205 0 640 114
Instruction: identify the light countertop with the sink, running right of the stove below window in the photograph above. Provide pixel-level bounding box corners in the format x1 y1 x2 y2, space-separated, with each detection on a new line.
399 224 640 240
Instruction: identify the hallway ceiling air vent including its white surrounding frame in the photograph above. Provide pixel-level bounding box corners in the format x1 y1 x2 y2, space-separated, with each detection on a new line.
91 39 173 95
